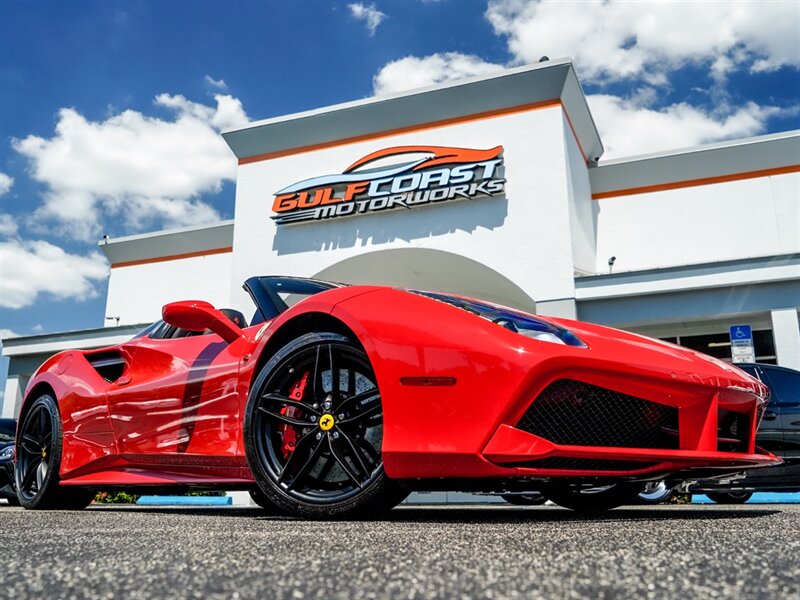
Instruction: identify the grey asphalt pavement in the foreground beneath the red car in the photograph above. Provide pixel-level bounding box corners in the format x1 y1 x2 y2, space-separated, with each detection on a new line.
0 505 800 600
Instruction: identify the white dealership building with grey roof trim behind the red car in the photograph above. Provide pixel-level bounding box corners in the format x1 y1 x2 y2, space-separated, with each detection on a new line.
2 60 800 416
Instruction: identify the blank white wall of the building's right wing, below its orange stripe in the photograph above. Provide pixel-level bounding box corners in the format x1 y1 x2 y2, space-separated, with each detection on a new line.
597 173 800 272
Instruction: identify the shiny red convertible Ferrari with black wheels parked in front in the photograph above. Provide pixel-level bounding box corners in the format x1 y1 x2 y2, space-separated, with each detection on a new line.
16 277 778 518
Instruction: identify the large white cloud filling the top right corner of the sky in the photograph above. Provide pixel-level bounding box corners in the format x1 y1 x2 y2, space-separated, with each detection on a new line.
486 0 800 84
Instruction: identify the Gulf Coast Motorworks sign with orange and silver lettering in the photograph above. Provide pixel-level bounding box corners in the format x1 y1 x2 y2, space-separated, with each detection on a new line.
272 146 506 225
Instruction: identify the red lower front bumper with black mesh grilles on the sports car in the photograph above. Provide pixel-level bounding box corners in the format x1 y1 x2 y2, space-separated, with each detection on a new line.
483 375 780 479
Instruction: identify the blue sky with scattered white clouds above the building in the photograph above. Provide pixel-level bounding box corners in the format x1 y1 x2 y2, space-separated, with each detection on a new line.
0 0 800 335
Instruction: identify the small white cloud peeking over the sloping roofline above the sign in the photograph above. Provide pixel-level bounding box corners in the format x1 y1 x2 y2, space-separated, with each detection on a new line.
372 52 503 96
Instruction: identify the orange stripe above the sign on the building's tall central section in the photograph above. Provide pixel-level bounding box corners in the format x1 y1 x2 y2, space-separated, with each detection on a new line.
239 98 586 165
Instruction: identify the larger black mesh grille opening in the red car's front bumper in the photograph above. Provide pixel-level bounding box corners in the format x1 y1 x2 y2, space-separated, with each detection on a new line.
517 379 679 450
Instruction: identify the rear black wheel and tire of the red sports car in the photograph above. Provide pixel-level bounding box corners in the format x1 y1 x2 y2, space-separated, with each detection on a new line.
14 395 94 510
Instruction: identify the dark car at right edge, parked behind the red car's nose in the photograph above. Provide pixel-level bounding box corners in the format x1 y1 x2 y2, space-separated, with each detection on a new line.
689 364 800 504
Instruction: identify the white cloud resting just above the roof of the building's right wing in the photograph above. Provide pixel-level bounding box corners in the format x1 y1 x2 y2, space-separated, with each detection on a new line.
587 94 780 159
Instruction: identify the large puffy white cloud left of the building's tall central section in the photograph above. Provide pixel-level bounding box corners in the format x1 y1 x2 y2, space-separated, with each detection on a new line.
13 94 247 241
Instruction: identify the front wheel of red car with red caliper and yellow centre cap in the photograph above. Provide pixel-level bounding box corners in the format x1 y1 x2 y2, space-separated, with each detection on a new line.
244 333 407 519
